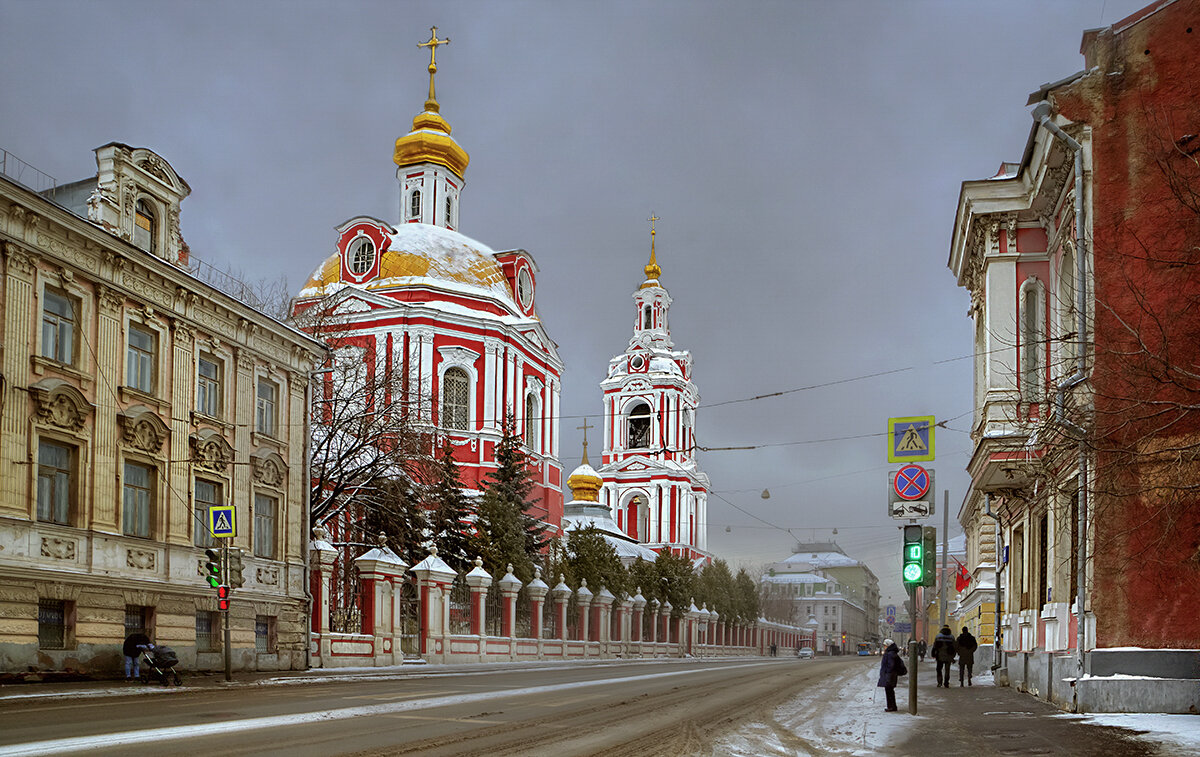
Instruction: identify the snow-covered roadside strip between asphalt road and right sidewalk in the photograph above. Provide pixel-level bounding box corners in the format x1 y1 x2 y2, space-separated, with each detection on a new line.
712 665 918 757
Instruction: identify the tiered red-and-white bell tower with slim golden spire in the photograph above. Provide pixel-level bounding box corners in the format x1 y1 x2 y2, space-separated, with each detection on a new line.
598 229 710 561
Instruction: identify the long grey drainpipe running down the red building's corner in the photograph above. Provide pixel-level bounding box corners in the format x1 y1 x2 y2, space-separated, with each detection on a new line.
1032 100 1088 691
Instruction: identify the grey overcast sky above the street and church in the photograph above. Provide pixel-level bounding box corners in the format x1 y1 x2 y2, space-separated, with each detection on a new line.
0 0 1148 597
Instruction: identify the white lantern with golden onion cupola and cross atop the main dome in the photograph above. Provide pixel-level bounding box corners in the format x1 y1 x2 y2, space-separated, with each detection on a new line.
392 26 470 229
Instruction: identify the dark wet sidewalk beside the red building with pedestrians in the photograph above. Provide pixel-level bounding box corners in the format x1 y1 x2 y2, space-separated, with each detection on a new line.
887 659 1166 757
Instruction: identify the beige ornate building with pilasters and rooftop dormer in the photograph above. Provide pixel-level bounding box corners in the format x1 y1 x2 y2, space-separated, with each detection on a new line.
0 143 324 674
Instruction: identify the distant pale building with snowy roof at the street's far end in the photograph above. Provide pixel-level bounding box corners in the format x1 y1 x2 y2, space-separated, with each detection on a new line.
760 542 882 654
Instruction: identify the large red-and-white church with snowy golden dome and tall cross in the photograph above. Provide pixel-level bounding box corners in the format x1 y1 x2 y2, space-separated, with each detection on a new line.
293 28 563 533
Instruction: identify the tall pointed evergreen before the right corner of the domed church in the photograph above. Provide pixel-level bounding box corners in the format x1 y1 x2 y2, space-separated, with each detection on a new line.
478 419 550 582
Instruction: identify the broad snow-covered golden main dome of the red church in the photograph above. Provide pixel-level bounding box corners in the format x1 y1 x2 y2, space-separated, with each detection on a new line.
299 223 520 313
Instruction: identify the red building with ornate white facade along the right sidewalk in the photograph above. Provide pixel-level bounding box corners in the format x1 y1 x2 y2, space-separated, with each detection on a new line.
949 0 1200 713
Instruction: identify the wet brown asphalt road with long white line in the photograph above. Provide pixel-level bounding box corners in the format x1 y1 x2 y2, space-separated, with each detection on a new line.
0 657 862 757
